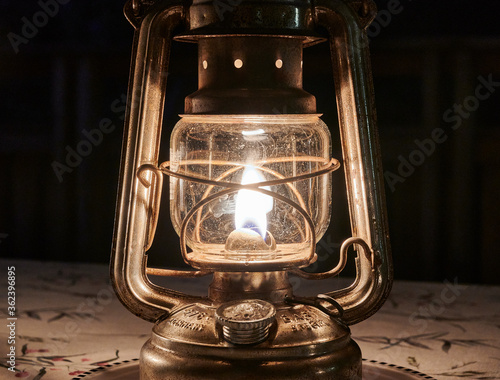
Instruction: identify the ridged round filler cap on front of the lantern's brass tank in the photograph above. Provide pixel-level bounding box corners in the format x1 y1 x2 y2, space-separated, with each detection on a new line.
215 299 276 344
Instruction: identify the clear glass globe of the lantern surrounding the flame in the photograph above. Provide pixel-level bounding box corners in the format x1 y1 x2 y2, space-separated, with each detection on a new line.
170 115 331 271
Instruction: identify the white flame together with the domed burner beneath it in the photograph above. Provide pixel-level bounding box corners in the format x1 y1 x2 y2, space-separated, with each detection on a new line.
226 166 276 252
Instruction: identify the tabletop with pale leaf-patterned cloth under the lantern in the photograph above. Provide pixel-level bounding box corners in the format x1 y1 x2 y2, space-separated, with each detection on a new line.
0 260 500 380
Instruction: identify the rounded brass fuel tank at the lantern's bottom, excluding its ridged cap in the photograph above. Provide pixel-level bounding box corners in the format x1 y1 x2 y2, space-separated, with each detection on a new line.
140 304 361 380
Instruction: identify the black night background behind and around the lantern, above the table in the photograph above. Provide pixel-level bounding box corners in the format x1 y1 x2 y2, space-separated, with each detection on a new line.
0 0 500 284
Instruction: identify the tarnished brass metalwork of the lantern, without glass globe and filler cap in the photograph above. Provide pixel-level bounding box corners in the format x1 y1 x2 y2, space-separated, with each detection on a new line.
111 0 392 380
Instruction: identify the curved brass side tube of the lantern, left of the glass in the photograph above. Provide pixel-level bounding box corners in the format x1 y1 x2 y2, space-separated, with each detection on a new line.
111 1 198 322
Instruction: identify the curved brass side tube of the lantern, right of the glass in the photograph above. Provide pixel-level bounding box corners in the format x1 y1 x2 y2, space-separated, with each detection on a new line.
315 0 392 324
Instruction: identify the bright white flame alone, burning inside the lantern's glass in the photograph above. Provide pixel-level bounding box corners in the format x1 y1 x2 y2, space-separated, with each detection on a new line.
234 166 273 239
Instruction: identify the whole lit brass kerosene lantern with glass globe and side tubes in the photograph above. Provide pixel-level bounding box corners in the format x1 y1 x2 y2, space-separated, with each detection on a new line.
111 0 392 380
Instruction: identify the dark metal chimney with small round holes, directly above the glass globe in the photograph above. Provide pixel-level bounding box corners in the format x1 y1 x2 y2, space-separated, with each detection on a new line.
185 36 316 115
